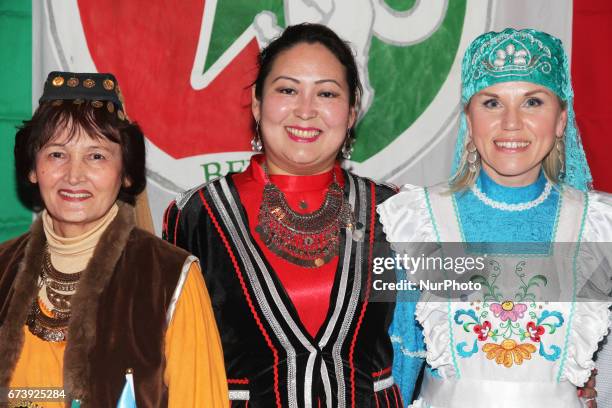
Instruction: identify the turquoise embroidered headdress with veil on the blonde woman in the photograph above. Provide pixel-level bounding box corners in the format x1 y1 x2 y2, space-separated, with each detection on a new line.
452 28 592 191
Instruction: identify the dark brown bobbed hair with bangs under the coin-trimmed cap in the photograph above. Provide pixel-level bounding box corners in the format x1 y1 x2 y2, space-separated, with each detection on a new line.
14 100 146 206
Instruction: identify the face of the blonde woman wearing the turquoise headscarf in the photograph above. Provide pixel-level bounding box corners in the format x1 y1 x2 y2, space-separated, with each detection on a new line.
466 81 567 186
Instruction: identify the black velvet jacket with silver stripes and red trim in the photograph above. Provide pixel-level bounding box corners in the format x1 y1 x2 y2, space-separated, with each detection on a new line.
164 173 401 408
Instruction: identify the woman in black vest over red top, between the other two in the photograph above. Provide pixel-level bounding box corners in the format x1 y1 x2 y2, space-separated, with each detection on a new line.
164 24 416 407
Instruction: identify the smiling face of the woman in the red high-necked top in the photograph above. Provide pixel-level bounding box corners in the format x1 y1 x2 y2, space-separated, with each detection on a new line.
252 43 355 175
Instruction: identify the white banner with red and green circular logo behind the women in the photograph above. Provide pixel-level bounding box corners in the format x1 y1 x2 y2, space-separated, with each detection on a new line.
0 0 608 240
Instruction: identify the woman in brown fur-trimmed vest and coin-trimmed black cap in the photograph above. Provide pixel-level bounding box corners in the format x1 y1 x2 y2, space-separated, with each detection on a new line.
0 72 227 407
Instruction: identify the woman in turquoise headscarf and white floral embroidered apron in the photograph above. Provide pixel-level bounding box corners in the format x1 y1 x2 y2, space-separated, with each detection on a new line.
378 29 612 408
